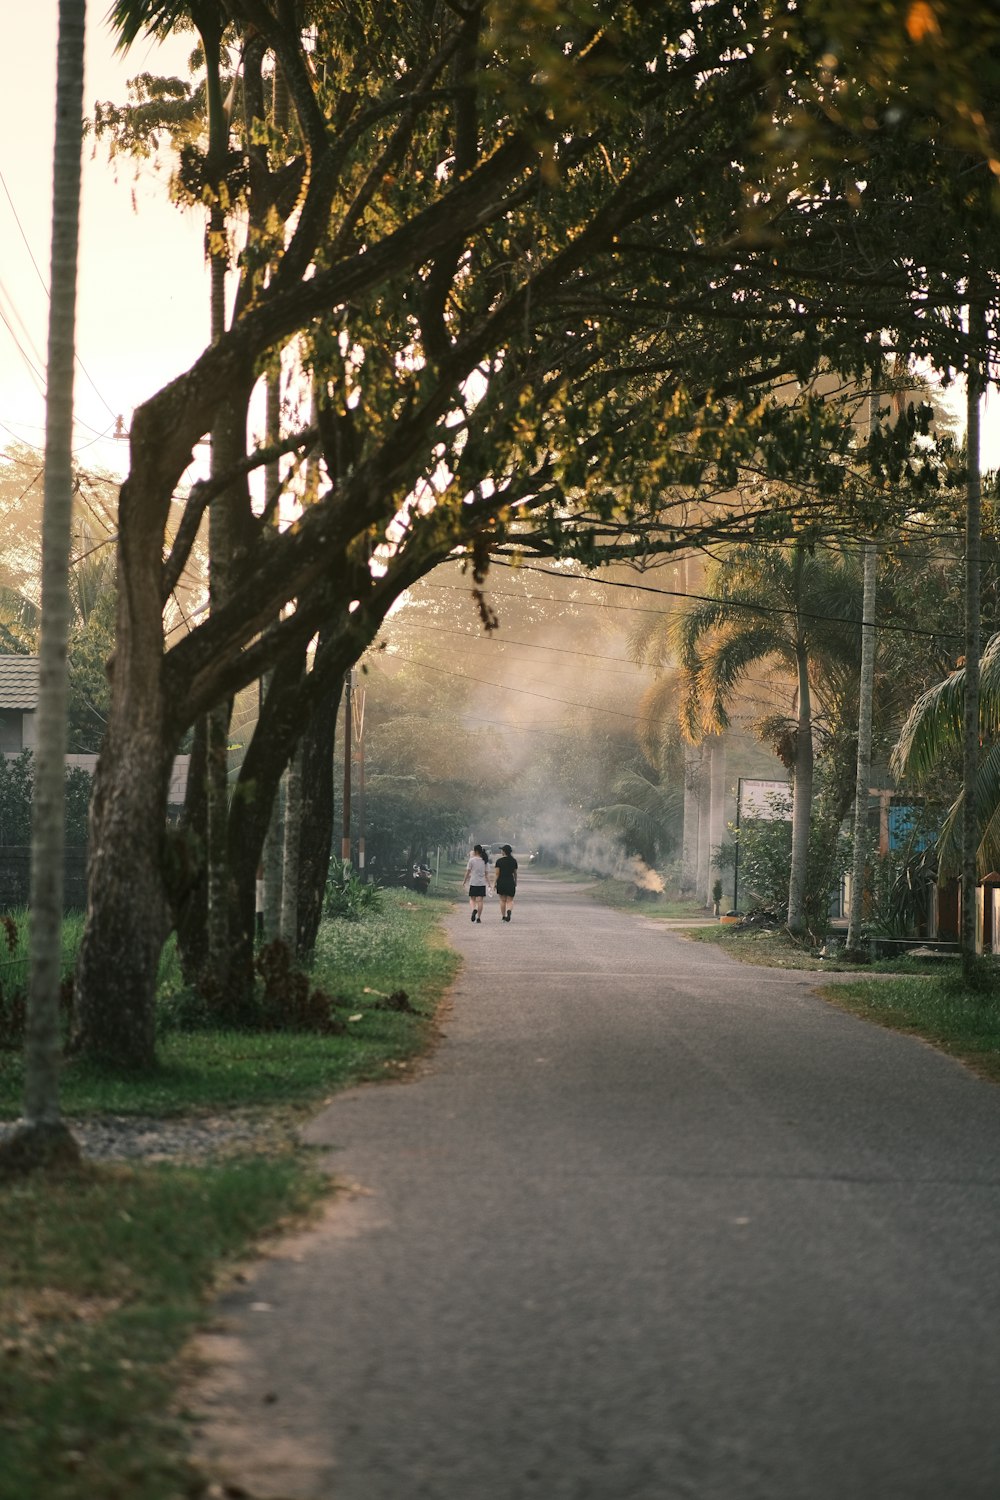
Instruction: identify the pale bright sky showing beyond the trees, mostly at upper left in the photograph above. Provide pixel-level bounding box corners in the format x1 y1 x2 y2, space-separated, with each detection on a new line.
0 0 1000 486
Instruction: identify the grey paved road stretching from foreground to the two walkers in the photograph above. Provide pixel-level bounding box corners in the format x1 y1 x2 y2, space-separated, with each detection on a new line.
191 878 1000 1500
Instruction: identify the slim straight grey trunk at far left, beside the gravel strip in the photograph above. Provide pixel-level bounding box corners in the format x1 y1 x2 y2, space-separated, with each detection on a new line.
24 0 87 1155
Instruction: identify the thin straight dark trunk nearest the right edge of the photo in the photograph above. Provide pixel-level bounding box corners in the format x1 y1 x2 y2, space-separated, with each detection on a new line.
961 289 987 981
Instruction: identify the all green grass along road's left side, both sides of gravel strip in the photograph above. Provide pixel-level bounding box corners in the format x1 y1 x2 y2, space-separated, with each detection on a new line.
0 879 457 1500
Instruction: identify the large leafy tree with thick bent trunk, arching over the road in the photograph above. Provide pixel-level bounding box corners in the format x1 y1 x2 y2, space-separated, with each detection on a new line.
78 0 995 1067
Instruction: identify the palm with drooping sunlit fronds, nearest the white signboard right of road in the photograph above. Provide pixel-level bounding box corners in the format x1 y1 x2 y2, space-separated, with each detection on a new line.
673 542 861 935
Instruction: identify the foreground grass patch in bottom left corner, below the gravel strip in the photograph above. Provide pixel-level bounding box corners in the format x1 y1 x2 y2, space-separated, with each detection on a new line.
0 1155 328 1500
